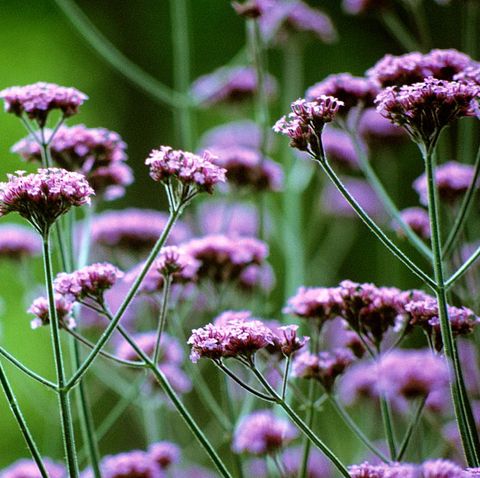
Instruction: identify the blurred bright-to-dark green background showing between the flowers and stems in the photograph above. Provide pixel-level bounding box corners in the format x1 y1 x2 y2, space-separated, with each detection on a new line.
0 0 476 468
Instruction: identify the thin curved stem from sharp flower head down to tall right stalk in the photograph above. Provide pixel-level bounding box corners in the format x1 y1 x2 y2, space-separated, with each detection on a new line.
316 152 436 289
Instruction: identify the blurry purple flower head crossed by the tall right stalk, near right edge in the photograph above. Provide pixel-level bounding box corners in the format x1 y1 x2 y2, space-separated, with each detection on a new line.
413 161 475 205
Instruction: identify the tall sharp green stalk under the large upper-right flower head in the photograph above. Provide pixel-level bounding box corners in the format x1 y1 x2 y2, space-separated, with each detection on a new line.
420 146 480 466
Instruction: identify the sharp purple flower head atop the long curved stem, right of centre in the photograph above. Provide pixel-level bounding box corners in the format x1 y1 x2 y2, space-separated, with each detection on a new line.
273 96 343 157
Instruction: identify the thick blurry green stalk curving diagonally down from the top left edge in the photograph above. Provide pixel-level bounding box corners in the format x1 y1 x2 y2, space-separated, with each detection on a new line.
54 0 191 109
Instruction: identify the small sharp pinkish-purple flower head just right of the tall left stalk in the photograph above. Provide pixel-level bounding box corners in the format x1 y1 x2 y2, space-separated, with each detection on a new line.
54 262 123 302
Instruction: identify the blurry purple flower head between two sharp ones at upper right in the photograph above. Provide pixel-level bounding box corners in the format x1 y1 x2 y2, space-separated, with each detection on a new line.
305 73 378 114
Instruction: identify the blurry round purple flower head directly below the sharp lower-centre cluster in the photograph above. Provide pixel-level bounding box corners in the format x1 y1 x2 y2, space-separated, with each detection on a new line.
232 410 298 455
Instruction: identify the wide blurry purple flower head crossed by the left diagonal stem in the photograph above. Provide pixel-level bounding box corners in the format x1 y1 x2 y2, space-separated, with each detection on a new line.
92 208 191 253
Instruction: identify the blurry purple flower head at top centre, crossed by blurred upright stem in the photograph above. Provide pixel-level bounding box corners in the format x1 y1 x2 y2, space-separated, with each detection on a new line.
191 66 277 106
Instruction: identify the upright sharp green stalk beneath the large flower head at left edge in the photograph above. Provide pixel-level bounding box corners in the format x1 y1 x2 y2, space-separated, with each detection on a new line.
43 236 78 478
